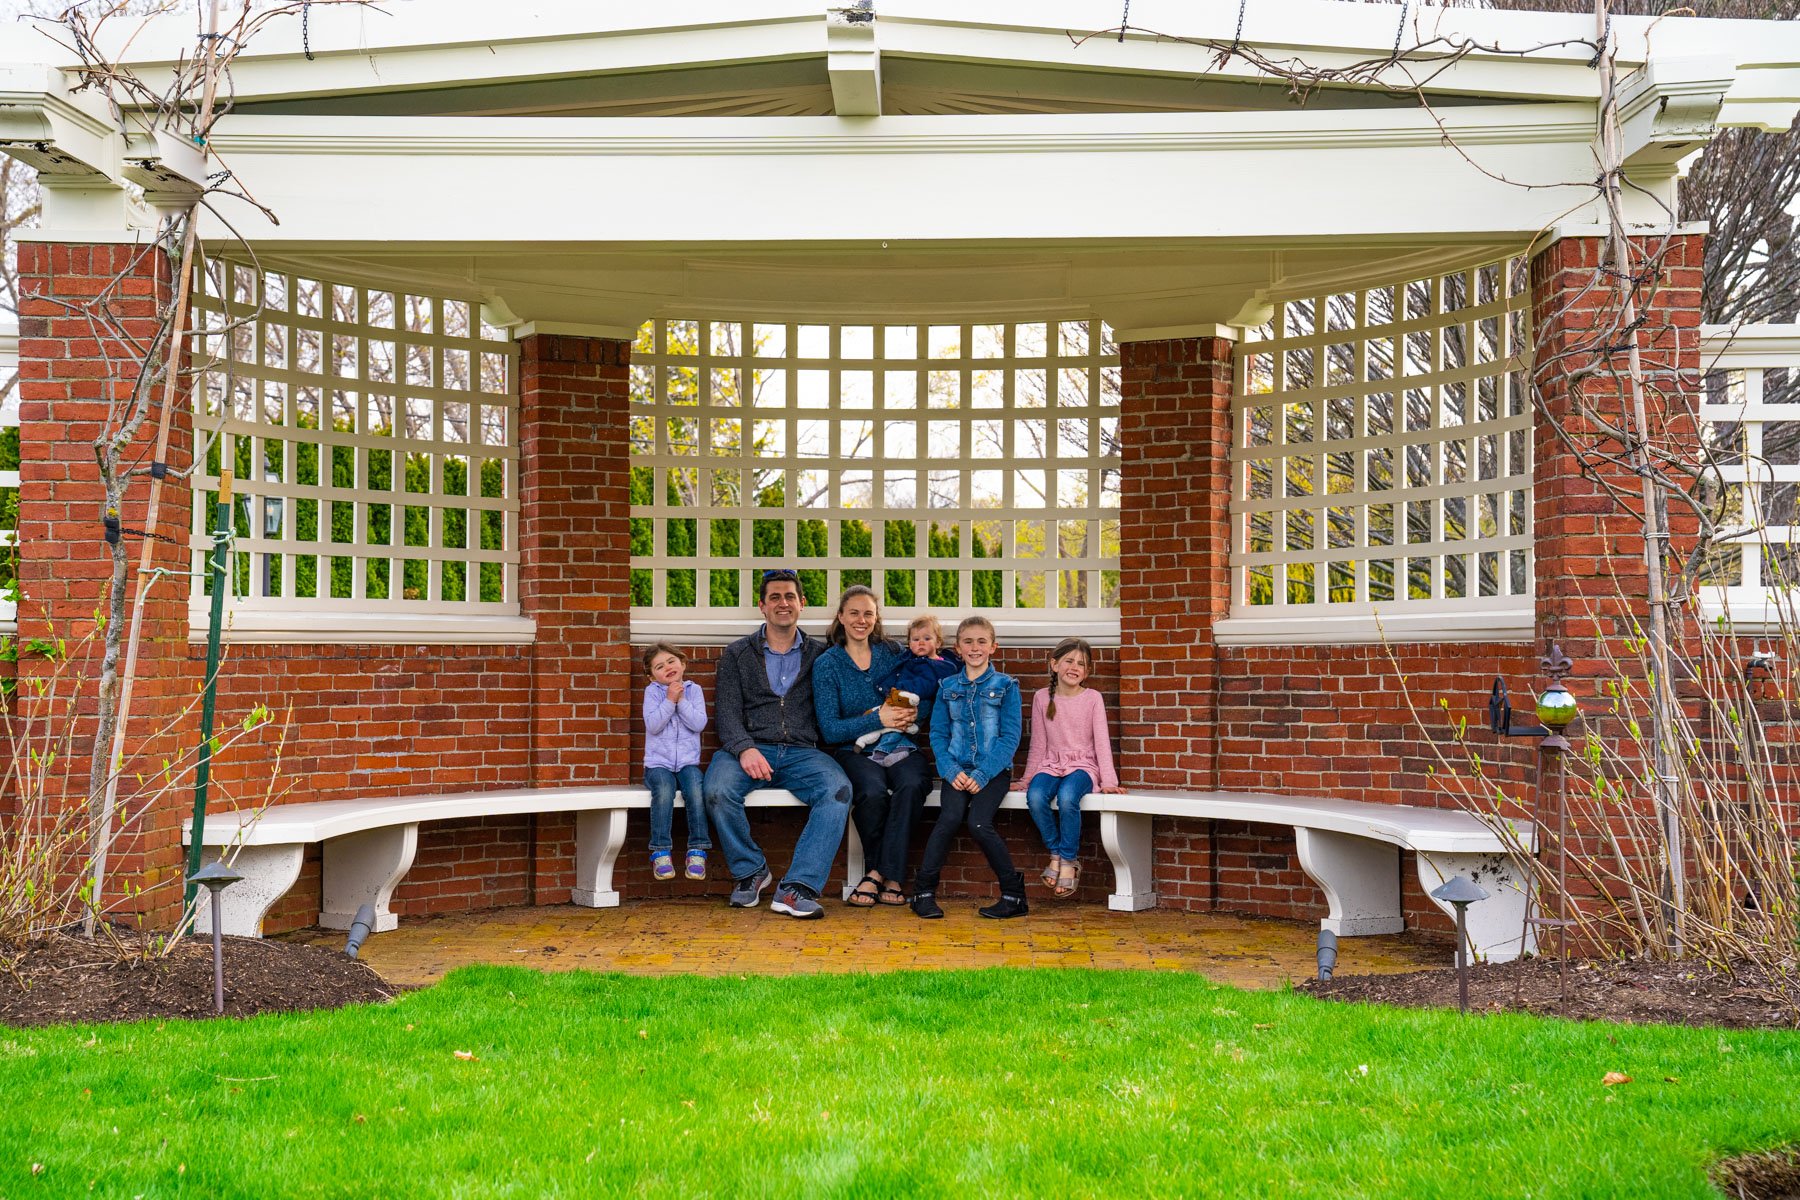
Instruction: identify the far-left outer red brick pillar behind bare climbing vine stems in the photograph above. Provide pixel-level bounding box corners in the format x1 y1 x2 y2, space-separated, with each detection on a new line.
18 243 202 927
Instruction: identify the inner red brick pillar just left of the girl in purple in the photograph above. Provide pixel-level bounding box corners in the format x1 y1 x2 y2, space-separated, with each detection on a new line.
518 335 632 903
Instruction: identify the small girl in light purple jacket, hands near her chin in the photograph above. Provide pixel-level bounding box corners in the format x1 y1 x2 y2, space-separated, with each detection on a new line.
644 642 713 880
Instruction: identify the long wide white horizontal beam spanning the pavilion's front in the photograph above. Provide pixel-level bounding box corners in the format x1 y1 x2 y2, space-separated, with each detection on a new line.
203 104 1634 248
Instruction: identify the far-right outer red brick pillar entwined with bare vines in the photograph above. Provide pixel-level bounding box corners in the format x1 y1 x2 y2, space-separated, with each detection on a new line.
1532 234 1705 945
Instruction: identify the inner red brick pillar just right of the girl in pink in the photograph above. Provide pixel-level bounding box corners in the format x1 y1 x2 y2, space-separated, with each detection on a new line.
1120 338 1231 788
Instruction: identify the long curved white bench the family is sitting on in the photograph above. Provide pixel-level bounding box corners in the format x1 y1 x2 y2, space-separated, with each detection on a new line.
182 786 1535 963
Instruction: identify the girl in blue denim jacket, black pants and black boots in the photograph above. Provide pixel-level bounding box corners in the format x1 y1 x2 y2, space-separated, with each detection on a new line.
913 617 1028 919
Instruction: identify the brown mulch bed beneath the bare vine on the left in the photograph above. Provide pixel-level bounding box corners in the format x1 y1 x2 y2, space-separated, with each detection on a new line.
0 932 396 1025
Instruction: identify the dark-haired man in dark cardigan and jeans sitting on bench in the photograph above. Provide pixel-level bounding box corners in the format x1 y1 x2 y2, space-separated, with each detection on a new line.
706 570 850 918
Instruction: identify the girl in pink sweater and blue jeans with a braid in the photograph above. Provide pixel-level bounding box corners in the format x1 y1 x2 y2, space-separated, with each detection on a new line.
1013 637 1121 900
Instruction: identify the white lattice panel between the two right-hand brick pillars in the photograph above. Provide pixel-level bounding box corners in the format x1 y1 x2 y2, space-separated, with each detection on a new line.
1231 259 1532 644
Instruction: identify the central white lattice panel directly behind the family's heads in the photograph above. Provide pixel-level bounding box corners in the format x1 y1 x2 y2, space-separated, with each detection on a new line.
632 318 1120 633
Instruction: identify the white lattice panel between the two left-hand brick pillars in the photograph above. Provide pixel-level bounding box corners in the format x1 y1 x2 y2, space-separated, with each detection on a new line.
191 261 518 628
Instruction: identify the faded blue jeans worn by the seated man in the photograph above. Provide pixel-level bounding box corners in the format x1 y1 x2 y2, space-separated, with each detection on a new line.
706 745 850 894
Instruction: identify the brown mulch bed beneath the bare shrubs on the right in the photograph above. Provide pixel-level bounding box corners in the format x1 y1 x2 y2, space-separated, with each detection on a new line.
1298 959 1800 1029
